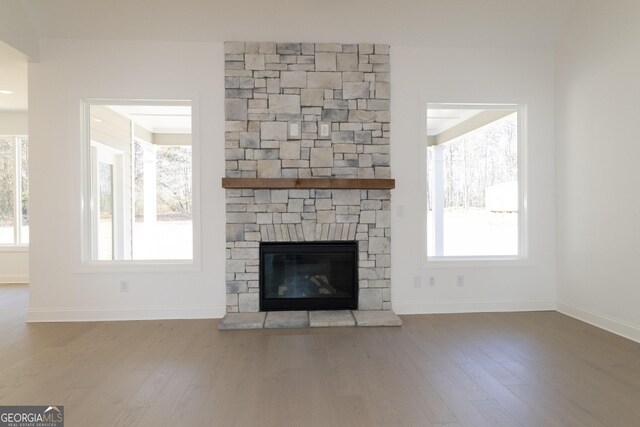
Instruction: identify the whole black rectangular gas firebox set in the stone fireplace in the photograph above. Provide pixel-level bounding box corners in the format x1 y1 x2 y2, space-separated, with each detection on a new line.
260 241 358 311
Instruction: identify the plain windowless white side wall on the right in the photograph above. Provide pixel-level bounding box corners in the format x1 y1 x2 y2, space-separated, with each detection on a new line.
556 0 640 341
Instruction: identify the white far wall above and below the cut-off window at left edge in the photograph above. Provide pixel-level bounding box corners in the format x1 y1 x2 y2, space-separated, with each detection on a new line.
0 112 29 283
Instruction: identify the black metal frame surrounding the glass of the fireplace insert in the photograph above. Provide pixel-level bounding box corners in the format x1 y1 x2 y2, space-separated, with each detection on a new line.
259 240 358 311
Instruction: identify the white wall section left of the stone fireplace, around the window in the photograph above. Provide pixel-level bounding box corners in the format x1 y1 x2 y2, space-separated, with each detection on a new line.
28 40 225 321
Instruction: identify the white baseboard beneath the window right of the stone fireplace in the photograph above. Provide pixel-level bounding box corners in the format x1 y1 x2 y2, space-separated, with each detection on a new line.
393 300 556 314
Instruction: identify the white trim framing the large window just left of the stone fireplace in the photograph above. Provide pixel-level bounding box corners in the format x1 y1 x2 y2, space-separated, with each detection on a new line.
75 98 202 273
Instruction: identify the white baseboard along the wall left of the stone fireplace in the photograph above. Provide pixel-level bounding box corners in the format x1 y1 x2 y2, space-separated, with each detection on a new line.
27 307 225 323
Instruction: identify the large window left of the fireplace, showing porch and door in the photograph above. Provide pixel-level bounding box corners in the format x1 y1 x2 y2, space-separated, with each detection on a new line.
85 101 193 261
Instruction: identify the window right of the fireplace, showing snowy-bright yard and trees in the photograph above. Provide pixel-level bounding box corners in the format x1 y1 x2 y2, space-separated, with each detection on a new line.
427 104 525 260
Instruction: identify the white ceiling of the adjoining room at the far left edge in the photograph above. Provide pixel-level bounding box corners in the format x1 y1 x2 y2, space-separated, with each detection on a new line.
0 42 28 112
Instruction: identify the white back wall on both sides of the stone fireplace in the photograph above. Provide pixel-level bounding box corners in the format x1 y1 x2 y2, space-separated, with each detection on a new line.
29 40 555 321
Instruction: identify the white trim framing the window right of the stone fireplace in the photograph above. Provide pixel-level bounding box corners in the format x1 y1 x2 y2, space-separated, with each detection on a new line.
419 102 532 269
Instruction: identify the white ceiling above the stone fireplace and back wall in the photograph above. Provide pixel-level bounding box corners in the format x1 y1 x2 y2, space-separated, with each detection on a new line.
21 0 578 48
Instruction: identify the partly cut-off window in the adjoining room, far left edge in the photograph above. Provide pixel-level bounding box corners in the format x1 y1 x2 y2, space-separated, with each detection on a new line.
0 136 29 246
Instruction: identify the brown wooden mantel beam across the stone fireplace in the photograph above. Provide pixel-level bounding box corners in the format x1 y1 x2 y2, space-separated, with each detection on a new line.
222 178 396 190
